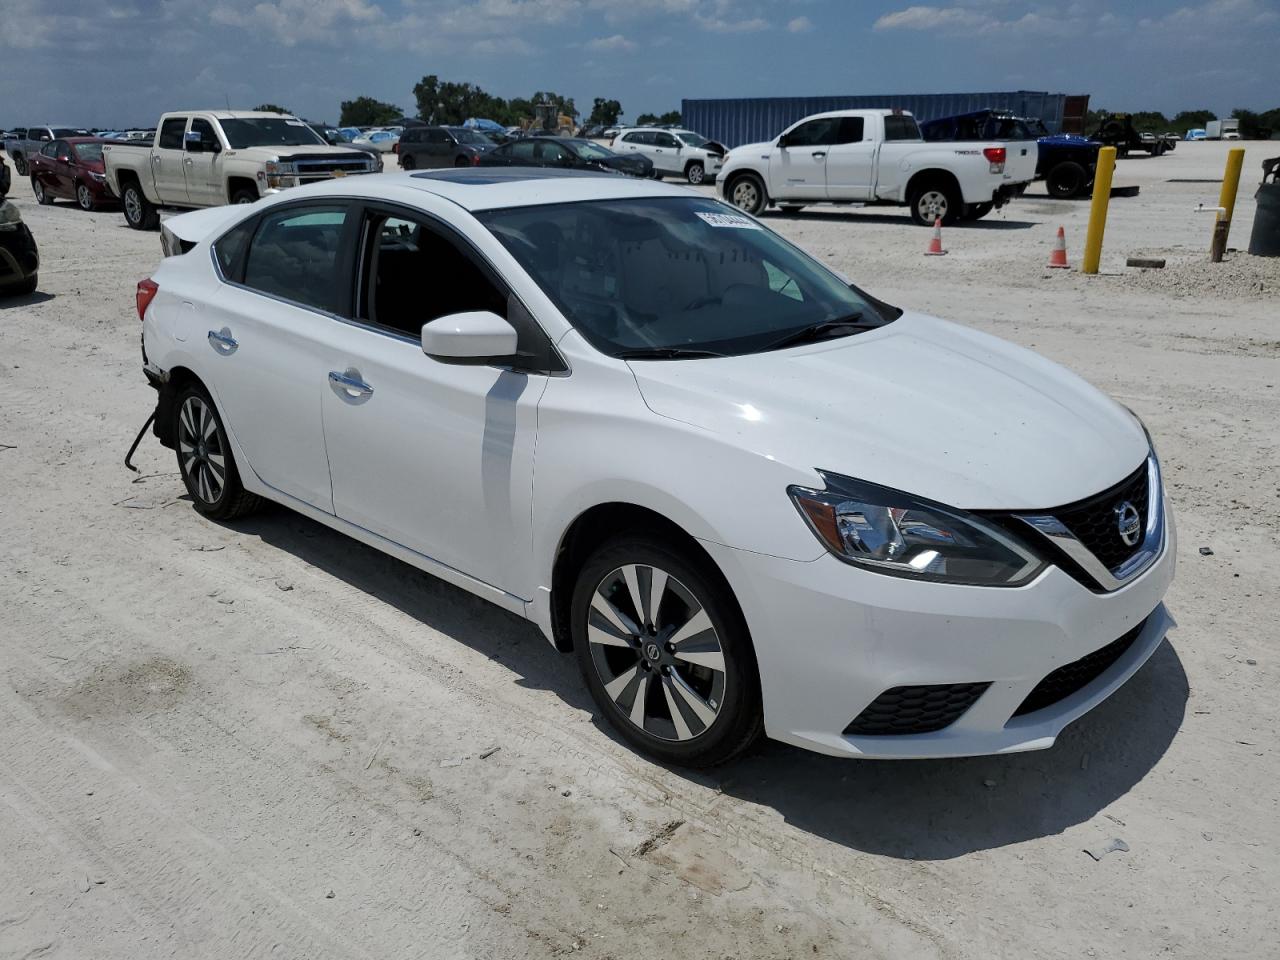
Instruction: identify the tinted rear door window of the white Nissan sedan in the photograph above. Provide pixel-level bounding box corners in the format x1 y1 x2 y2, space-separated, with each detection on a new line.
240 205 347 312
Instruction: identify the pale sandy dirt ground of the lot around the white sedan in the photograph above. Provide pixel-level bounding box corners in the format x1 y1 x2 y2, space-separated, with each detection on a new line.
0 143 1280 960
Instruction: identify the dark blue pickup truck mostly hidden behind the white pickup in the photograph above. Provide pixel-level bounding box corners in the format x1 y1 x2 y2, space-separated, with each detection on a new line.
920 110 1102 200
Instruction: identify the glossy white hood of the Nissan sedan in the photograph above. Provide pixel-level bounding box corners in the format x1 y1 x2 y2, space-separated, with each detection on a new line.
630 314 1148 509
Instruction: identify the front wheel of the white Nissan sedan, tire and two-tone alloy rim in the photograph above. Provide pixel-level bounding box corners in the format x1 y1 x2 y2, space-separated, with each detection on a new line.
571 534 764 767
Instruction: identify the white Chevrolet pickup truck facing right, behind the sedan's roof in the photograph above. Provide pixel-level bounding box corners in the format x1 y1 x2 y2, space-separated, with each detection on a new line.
102 110 376 230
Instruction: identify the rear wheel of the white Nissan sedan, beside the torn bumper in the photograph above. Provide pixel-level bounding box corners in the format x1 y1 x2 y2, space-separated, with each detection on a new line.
174 384 260 520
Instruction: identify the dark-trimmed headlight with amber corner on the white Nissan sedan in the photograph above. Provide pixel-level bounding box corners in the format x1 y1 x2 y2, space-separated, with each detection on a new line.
787 471 1046 586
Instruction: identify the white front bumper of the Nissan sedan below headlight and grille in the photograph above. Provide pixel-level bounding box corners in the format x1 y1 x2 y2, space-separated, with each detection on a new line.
703 503 1176 759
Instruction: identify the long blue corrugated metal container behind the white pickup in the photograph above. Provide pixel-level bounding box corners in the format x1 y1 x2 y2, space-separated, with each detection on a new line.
681 90 1089 147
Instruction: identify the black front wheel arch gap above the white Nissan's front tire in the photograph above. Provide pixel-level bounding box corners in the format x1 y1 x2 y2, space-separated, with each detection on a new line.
550 500 745 653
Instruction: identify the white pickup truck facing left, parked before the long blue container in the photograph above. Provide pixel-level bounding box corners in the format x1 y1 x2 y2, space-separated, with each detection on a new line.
719 110 1039 225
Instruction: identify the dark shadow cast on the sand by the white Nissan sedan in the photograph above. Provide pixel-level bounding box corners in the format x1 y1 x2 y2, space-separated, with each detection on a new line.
234 507 1190 860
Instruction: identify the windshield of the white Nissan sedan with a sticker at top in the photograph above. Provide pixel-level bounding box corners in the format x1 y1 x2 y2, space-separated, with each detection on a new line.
476 197 900 358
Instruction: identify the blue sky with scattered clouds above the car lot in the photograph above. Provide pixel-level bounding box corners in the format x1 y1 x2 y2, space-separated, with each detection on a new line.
0 0 1280 125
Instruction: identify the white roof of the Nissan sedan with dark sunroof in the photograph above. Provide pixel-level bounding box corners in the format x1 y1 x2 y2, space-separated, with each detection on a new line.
278 166 703 210
